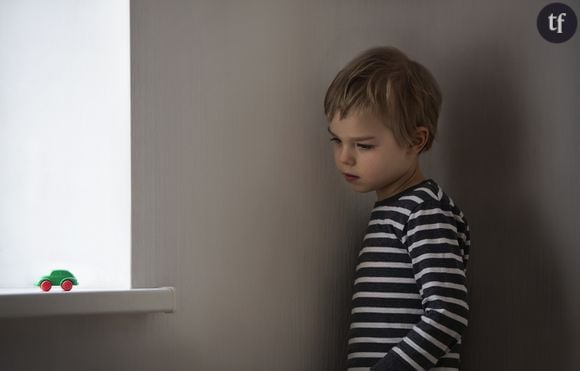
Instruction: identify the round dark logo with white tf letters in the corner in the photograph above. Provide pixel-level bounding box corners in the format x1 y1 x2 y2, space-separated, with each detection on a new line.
537 3 578 43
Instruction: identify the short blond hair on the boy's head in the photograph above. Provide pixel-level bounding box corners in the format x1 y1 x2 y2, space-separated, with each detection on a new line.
324 47 442 152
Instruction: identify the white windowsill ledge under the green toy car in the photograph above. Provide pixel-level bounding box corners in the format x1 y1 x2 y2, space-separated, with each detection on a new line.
0 287 175 318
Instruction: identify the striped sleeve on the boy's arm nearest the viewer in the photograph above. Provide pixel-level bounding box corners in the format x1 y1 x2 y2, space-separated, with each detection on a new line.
371 202 469 371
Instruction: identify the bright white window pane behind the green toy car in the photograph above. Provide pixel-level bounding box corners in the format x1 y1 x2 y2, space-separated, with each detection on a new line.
0 0 131 289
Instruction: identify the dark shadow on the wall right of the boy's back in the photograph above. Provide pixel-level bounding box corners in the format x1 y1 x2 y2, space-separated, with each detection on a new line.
444 45 573 371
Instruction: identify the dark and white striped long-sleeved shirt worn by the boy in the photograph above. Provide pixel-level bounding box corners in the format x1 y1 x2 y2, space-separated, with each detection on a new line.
347 179 470 371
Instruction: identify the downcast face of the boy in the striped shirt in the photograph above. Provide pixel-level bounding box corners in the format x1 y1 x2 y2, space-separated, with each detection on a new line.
329 112 423 200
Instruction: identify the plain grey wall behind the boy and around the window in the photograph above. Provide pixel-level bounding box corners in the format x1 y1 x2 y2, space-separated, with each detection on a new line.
0 0 580 371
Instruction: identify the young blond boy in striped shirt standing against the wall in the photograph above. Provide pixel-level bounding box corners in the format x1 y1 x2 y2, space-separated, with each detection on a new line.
324 47 470 371
